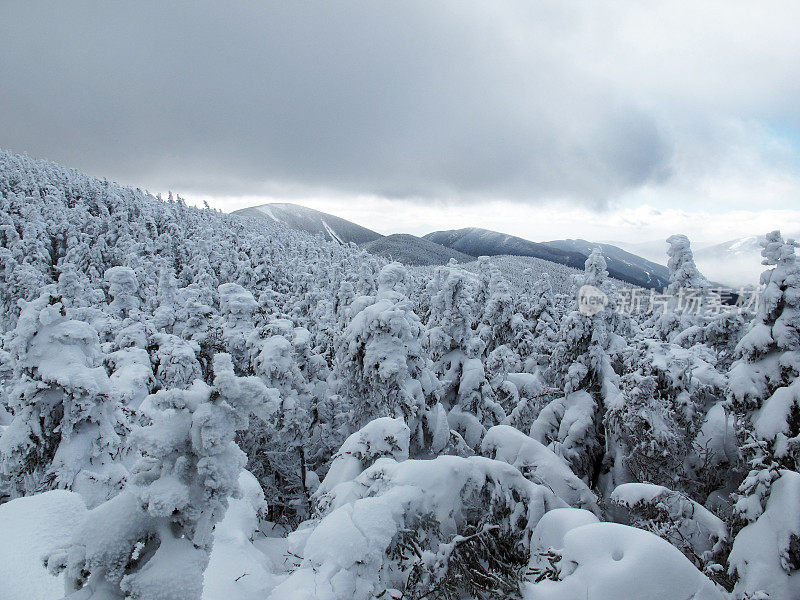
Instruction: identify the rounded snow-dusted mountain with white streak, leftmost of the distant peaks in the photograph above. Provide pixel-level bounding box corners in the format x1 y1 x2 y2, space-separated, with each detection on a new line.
232 203 383 244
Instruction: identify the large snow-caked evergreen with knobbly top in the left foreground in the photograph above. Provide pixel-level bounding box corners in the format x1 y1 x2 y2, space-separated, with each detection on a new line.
47 354 274 600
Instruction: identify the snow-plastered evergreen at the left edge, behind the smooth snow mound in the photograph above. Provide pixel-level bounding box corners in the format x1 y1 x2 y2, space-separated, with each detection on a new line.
0 286 127 505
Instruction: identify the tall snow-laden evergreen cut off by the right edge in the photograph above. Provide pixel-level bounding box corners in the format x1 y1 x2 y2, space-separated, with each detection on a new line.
729 231 800 600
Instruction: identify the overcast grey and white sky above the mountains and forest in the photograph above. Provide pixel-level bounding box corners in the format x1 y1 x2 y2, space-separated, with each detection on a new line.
0 0 800 245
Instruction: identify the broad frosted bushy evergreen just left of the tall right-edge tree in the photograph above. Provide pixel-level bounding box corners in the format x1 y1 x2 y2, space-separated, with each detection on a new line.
606 338 735 501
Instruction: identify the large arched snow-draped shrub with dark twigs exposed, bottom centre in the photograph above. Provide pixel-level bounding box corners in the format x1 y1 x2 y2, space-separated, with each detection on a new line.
270 456 565 600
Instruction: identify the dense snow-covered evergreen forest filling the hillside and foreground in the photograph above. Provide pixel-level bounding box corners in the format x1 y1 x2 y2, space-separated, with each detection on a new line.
0 152 800 600
